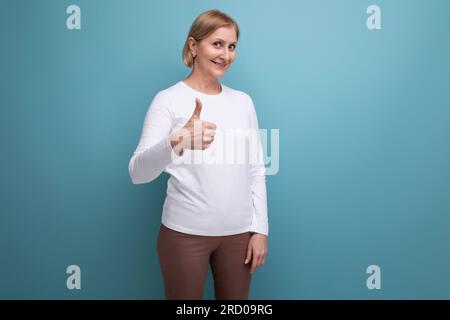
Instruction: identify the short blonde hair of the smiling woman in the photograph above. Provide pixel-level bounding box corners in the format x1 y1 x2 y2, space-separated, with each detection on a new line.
182 10 239 68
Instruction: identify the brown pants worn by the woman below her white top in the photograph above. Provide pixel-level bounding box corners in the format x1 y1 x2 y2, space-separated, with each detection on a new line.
157 224 251 300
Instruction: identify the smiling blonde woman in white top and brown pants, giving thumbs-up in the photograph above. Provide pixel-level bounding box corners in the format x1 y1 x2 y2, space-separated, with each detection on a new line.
129 10 268 299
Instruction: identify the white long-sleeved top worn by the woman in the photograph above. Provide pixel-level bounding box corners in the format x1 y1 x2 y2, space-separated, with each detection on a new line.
128 81 268 236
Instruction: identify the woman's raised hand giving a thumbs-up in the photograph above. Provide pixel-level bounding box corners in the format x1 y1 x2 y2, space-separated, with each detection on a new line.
170 98 216 156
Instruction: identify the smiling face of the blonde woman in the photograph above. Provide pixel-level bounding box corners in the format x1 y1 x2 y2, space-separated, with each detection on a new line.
189 26 237 79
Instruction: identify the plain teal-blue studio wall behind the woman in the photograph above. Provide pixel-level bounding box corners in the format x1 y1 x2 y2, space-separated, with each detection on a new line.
0 0 450 299
